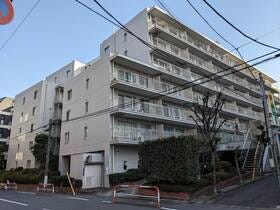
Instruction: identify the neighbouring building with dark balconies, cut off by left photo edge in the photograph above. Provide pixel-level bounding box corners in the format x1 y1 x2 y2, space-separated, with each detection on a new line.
0 97 13 143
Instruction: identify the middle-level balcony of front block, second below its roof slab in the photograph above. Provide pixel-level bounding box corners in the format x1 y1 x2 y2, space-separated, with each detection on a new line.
113 101 194 125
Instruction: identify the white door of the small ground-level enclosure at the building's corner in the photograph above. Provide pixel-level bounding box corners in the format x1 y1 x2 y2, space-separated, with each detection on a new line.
83 165 102 189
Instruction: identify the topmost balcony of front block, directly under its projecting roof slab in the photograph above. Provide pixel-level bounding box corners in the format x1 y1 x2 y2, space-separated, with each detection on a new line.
112 69 192 102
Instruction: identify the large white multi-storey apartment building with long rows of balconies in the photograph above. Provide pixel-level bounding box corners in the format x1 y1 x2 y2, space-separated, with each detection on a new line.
8 7 276 188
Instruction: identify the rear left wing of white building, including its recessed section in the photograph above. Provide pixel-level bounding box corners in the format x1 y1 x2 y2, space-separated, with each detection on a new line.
7 61 84 169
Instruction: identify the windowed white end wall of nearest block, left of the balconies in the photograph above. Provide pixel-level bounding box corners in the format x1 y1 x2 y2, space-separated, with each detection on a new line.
60 57 112 186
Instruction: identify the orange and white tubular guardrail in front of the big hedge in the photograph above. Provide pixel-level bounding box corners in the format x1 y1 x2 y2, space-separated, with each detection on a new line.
112 185 160 208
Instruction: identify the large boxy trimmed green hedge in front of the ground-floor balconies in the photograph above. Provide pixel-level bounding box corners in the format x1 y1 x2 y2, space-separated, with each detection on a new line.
139 136 199 184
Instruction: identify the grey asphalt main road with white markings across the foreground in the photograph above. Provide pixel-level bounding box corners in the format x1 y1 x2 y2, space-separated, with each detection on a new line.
0 191 256 210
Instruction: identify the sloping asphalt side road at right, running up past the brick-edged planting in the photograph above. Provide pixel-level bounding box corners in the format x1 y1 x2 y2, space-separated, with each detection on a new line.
213 176 280 208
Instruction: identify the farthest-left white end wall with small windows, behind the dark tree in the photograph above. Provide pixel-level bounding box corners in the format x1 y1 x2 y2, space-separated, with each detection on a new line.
7 81 45 169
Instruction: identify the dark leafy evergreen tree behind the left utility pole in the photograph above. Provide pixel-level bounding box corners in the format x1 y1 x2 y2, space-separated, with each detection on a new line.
31 133 58 170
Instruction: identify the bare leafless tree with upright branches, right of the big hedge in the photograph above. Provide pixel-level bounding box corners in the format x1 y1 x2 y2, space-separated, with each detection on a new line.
191 93 226 194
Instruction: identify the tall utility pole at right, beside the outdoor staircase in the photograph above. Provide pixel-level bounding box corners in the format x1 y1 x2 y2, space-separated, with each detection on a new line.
259 73 280 185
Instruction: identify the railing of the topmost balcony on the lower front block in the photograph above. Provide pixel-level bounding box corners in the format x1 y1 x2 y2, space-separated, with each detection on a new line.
114 69 192 100
